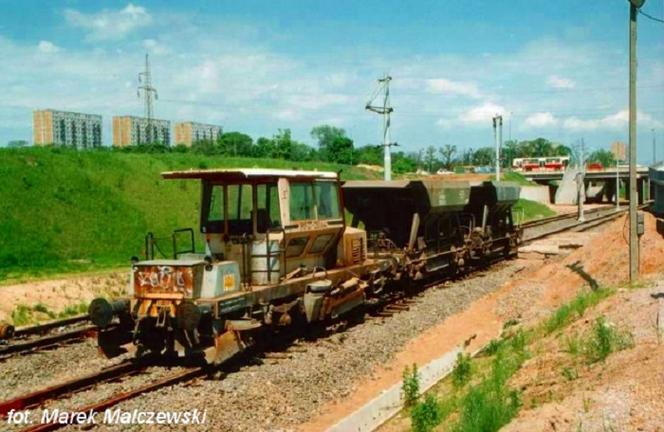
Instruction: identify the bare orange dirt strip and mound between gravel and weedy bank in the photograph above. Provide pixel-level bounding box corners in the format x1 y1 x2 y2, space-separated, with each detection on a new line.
308 215 664 430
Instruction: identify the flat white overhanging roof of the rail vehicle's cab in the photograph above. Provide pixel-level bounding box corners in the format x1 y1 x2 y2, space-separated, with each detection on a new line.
161 168 338 181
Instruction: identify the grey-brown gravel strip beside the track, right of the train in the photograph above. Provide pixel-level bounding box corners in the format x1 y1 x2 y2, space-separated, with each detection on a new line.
70 261 522 431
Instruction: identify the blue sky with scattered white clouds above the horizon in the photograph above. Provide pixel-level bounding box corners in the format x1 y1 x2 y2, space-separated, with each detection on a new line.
0 0 664 163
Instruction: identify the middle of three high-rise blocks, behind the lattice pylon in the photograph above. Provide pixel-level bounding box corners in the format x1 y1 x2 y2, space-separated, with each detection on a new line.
113 116 171 147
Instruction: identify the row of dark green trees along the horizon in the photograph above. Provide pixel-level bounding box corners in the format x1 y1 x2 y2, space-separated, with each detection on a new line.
40 125 613 173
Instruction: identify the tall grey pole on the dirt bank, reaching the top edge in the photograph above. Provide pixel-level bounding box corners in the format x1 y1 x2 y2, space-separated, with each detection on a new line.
629 0 645 283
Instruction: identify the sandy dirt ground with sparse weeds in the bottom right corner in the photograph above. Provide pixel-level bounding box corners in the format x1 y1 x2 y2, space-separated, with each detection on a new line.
504 284 664 432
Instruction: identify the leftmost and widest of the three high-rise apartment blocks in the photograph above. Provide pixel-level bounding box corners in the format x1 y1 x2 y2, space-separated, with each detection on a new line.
32 109 101 148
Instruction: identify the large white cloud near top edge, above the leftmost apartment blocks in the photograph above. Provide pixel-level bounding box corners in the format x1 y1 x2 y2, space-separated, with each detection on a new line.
64 3 152 41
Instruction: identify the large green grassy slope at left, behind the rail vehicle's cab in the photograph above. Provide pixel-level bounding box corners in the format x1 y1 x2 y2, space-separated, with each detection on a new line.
0 148 376 280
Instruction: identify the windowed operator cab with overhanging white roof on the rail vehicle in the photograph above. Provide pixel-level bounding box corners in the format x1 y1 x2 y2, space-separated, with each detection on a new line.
162 169 344 288
